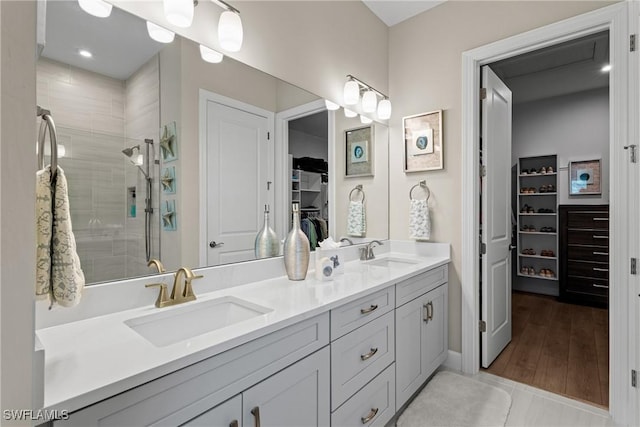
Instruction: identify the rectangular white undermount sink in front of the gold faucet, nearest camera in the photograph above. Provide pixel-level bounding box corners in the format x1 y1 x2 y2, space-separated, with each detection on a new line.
124 296 273 347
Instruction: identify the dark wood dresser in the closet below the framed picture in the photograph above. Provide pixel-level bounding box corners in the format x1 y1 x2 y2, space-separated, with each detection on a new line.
558 205 609 305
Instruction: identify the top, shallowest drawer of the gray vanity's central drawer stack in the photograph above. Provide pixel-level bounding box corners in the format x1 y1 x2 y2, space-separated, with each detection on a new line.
331 286 395 340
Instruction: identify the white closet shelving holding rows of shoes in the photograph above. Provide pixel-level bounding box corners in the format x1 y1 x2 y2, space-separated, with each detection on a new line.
516 155 558 282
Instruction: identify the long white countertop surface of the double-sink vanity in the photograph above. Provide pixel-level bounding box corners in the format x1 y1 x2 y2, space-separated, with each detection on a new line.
36 252 450 412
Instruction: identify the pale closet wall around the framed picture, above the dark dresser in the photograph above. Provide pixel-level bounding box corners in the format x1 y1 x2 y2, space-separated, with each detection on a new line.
511 88 609 205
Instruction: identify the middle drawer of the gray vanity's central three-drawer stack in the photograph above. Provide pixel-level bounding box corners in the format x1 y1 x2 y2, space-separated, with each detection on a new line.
331 311 395 410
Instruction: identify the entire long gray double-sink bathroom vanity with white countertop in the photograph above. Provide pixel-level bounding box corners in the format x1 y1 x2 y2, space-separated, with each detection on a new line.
37 241 449 427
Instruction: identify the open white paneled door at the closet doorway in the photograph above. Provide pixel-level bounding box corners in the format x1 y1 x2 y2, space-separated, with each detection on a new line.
481 66 511 368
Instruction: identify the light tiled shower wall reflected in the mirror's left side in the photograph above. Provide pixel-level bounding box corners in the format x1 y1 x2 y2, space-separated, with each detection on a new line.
37 58 158 283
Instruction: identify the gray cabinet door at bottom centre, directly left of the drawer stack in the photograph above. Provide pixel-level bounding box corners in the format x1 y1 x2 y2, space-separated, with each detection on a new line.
242 347 330 427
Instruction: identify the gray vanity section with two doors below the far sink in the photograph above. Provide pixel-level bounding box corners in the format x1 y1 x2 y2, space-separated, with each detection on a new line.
396 266 449 409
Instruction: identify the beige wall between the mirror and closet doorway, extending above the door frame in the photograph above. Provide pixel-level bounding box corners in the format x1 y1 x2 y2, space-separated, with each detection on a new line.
389 1 611 351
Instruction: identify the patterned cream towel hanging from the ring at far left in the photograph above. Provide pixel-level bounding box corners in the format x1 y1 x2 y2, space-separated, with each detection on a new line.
36 166 84 307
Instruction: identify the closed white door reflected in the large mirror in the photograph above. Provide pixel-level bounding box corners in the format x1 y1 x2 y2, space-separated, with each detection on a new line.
206 100 273 266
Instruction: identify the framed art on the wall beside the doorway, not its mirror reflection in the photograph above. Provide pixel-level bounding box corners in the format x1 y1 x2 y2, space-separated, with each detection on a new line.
402 110 444 172
